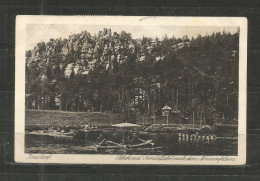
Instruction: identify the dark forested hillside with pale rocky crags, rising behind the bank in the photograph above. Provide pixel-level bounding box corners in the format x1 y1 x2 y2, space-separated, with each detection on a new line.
26 29 239 123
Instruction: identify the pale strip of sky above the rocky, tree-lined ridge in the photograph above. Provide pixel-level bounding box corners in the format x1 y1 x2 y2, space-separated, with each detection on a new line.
26 24 238 50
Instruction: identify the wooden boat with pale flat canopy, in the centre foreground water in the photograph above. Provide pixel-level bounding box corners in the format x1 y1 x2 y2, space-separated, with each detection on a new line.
97 123 154 150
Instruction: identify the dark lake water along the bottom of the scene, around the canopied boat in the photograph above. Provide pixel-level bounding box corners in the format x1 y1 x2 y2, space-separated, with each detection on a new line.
25 133 238 155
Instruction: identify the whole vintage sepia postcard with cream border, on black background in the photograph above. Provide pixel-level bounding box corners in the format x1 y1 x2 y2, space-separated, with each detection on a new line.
15 16 247 165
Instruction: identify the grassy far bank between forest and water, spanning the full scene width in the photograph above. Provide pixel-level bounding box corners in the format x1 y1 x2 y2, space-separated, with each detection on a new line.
25 110 237 135
